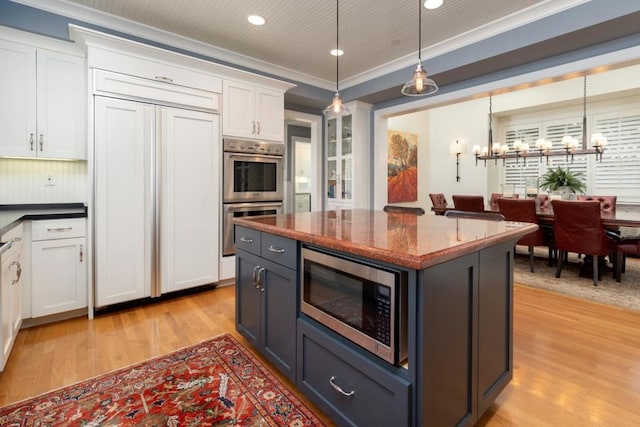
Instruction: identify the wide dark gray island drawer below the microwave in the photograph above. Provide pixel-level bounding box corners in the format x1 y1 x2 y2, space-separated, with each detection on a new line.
297 318 411 426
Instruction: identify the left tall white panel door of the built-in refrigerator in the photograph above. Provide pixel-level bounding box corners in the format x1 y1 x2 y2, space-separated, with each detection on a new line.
94 97 154 307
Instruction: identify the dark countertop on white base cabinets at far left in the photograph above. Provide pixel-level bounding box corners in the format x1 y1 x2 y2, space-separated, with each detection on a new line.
0 203 87 235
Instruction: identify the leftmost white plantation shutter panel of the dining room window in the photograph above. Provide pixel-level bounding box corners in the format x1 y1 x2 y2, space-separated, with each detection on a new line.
503 123 540 194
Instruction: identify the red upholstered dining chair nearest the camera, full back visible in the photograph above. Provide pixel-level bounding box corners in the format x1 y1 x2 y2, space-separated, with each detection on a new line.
551 200 617 286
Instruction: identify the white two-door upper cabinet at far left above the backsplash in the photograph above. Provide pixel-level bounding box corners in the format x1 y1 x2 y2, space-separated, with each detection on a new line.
0 40 86 159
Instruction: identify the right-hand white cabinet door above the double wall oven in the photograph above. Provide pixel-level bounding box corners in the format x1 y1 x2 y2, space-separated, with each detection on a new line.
256 88 284 141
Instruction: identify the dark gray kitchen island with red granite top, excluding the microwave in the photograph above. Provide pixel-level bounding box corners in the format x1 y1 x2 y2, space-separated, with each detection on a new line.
234 209 537 426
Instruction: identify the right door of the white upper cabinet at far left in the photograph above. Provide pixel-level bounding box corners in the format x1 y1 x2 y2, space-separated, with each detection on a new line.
36 49 87 159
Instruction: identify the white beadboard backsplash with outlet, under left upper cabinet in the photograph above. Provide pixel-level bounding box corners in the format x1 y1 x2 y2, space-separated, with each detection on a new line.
0 158 88 205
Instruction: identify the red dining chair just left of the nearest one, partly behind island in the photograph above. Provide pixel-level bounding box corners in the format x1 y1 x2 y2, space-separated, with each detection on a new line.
496 198 553 273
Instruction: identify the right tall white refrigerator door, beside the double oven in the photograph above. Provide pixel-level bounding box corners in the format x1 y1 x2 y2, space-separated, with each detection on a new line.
159 108 222 293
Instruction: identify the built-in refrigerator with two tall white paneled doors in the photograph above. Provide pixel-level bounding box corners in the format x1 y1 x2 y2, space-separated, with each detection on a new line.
93 96 221 307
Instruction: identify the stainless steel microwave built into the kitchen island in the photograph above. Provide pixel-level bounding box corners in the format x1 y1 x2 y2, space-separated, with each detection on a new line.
300 247 407 364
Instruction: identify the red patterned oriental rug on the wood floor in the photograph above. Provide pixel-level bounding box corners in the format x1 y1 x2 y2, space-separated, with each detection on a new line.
0 334 323 427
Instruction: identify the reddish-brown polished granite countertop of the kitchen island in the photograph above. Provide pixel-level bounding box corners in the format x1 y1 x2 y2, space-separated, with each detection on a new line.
233 209 538 269
